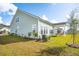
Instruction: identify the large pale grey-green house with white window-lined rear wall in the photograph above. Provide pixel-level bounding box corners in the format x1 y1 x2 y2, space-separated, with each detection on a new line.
10 9 53 38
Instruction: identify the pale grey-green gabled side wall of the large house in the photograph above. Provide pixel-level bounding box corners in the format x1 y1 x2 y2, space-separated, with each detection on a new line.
11 10 38 37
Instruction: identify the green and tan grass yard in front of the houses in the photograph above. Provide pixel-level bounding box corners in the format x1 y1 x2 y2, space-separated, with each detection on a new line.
0 35 79 56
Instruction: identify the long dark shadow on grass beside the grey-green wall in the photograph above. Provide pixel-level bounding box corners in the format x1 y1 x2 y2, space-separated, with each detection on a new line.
0 35 33 45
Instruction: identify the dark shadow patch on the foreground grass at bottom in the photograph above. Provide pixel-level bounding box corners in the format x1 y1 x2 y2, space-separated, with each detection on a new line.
40 47 66 56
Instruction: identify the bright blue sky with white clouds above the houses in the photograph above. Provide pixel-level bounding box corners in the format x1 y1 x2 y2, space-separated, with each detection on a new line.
0 3 79 25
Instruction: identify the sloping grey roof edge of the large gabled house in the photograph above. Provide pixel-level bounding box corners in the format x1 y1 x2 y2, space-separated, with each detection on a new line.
10 8 67 26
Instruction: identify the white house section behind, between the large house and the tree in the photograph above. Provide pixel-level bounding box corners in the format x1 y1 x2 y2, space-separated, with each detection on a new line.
53 22 69 34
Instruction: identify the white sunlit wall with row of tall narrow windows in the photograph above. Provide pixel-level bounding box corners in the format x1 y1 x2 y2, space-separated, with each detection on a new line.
38 20 53 37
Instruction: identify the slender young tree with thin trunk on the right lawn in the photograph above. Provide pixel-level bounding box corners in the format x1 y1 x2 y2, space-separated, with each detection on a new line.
69 10 78 44
